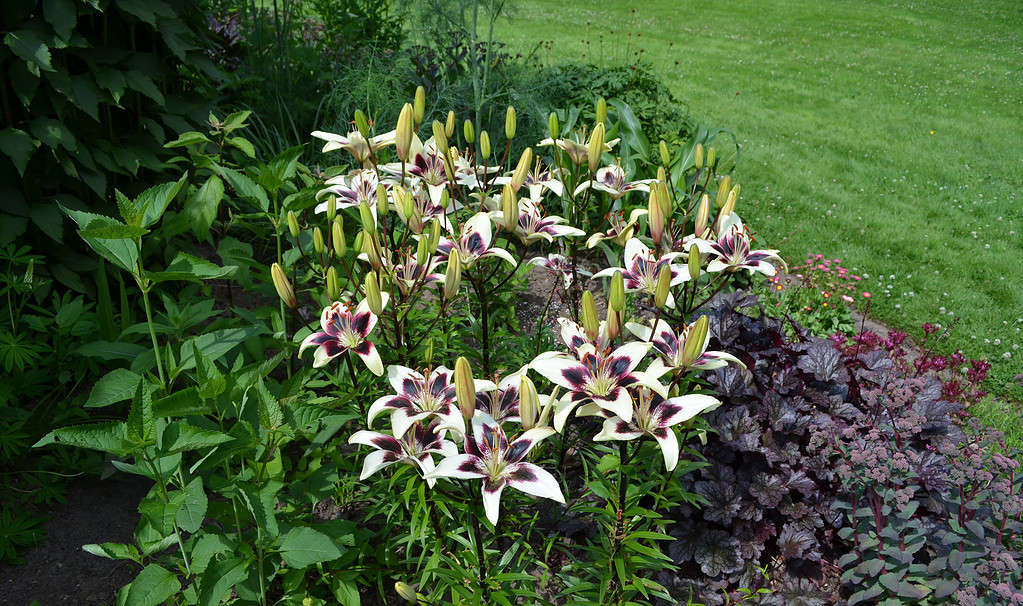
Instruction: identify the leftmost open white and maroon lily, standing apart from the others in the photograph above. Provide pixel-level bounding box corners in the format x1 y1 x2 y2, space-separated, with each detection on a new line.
299 293 389 377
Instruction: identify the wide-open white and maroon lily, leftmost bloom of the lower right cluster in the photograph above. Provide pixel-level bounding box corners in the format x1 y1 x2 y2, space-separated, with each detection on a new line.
529 342 667 431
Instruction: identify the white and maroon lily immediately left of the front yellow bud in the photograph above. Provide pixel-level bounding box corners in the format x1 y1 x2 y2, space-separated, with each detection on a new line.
366 364 495 438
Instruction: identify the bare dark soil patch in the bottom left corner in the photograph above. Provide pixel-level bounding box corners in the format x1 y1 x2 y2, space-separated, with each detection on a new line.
0 478 152 606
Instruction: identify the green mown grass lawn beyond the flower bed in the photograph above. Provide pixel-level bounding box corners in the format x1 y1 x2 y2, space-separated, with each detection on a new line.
498 0 1023 411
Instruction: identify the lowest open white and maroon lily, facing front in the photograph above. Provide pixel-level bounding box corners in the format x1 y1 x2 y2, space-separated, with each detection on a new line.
427 410 565 525
